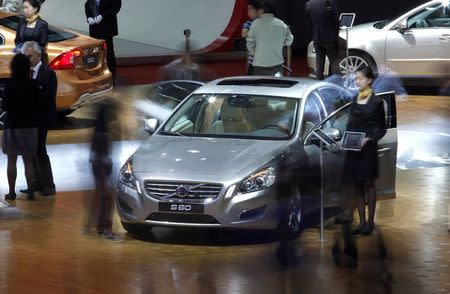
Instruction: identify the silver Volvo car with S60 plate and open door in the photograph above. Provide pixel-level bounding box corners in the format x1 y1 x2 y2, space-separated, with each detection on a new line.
117 77 397 237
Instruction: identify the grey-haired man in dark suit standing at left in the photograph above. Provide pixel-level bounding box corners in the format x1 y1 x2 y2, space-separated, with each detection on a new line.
22 42 58 196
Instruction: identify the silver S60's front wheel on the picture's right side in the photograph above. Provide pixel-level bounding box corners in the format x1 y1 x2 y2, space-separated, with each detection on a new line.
277 185 303 240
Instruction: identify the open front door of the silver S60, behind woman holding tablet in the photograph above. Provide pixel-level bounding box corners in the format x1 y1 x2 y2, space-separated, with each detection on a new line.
305 92 398 202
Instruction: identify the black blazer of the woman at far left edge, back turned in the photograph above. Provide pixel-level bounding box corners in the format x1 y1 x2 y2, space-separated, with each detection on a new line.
2 79 40 129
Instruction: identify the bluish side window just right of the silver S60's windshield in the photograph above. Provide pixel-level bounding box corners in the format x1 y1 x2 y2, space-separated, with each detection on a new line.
302 91 325 139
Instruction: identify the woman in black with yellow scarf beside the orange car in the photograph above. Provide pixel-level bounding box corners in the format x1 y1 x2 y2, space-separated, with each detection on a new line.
15 0 48 52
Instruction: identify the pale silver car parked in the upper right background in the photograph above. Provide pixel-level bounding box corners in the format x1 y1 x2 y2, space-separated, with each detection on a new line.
308 0 450 82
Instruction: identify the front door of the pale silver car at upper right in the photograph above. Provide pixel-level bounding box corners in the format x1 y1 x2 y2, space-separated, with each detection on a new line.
386 2 450 77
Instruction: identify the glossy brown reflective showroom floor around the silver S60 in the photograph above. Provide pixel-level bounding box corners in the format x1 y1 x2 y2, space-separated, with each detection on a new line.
0 89 450 294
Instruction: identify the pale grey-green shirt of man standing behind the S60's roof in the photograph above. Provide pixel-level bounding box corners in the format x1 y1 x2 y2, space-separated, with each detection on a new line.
247 13 294 67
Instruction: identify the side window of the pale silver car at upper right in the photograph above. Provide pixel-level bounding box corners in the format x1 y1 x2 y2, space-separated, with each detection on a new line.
408 3 450 29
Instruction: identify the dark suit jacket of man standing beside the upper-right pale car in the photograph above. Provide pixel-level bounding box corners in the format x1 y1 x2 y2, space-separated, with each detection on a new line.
305 0 339 43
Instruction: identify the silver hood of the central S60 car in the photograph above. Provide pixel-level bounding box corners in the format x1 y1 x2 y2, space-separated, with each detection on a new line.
132 135 290 180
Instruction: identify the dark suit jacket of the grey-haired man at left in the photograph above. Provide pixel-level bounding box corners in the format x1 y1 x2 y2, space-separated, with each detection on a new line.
36 64 58 128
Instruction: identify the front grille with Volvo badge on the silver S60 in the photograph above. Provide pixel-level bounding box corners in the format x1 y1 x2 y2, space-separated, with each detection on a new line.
144 181 222 200
